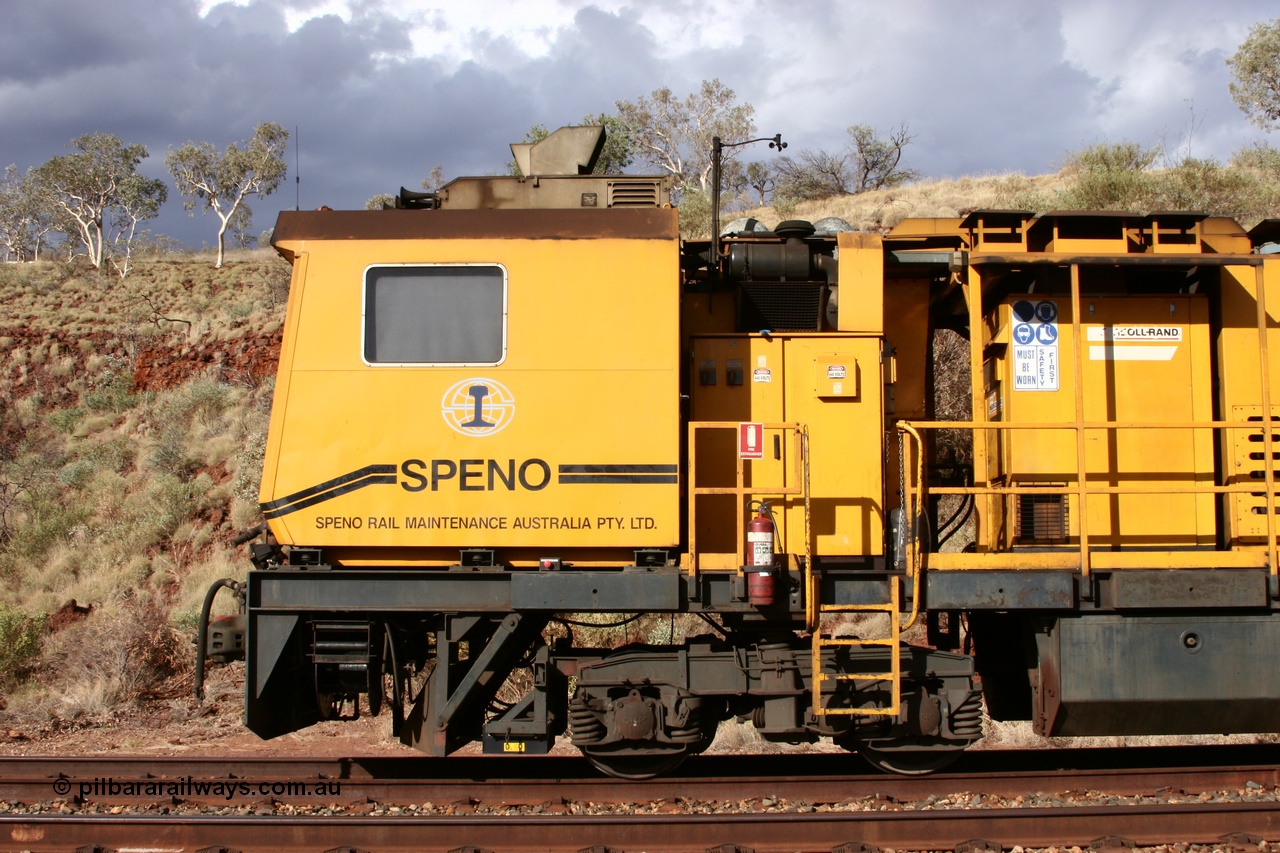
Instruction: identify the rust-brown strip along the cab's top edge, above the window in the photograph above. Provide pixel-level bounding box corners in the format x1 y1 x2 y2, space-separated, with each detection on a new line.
271 209 680 243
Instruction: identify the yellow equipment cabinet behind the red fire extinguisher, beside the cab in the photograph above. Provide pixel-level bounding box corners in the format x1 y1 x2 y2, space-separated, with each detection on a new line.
690 333 883 569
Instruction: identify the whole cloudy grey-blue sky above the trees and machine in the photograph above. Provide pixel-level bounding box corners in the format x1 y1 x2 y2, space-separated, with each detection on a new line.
0 0 1280 246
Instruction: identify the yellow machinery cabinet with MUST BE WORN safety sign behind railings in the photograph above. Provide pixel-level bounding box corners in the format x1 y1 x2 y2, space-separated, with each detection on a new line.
986 295 1216 548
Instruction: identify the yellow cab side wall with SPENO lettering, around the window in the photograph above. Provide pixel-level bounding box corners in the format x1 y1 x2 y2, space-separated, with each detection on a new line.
261 222 681 550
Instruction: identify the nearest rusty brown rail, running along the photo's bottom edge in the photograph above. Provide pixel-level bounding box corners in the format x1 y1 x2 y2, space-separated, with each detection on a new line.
0 803 1280 853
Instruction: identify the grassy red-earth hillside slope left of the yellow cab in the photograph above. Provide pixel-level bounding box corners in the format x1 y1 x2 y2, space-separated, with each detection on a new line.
0 251 289 720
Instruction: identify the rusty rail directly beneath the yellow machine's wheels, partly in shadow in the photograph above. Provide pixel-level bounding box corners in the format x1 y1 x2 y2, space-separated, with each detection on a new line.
0 745 1280 806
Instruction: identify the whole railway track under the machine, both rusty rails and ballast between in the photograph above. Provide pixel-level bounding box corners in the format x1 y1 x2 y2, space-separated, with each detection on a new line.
0 747 1280 853
